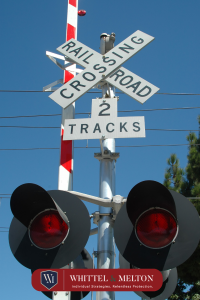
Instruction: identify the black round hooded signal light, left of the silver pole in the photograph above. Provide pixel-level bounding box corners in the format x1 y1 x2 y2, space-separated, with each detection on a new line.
9 183 90 269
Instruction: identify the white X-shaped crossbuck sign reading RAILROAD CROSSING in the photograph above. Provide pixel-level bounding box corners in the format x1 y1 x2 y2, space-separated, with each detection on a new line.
49 30 159 108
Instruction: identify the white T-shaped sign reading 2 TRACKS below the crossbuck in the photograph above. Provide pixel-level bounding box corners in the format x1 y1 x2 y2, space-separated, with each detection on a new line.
63 98 145 140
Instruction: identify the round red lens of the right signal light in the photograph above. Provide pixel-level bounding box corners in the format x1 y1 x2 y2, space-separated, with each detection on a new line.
136 208 177 248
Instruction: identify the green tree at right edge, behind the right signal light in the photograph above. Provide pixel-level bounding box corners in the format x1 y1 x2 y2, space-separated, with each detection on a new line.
164 116 200 300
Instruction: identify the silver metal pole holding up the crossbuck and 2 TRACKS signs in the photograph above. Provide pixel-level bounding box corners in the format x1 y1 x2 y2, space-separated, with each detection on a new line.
96 86 115 300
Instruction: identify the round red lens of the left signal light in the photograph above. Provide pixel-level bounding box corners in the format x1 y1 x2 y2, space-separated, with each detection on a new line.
29 210 69 249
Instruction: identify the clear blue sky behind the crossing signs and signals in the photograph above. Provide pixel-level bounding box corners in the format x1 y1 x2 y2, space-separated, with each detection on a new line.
0 0 200 300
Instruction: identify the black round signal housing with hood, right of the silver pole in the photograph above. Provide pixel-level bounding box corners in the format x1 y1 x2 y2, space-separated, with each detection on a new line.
114 180 200 271
